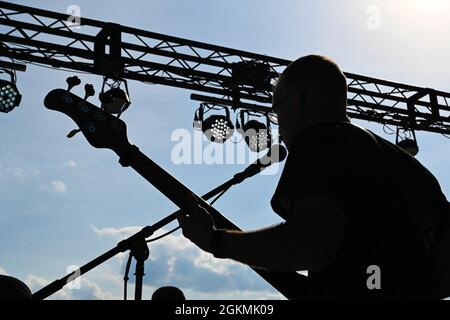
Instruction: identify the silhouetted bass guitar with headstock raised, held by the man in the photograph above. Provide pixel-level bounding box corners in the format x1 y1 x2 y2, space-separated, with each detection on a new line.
44 89 306 299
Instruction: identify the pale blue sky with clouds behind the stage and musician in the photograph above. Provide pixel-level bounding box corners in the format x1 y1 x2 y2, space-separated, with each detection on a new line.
0 0 450 299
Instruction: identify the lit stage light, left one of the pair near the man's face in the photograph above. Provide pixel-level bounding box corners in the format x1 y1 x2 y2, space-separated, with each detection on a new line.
194 103 234 143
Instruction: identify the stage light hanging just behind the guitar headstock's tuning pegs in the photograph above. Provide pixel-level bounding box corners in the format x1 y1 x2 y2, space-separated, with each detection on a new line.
99 79 131 116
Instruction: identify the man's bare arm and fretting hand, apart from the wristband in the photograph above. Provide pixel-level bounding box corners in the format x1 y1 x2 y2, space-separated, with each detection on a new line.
179 195 344 271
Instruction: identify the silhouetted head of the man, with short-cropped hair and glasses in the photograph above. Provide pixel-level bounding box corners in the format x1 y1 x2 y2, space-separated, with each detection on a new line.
272 55 349 149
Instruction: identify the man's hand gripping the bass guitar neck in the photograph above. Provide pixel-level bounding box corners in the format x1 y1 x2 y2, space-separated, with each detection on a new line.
177 195 214 252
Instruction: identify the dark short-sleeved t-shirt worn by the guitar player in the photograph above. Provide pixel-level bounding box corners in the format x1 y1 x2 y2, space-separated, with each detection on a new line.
271 122 448 298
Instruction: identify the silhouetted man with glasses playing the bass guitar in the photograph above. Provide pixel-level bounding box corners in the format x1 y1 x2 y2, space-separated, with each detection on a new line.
179 55 450 299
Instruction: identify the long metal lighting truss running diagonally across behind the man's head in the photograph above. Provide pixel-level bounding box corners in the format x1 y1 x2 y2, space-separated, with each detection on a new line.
0 1 450 134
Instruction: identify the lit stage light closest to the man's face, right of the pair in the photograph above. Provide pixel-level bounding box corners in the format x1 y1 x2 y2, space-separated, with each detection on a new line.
236 111 272 152
